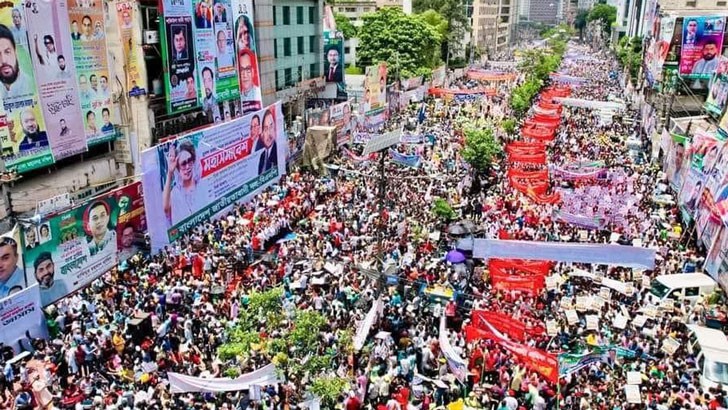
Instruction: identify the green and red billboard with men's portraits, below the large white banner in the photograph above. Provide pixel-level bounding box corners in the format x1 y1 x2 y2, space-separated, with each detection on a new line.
23 182 145 306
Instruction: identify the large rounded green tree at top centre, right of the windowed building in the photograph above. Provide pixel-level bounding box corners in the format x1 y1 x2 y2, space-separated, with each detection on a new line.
357 7 442 78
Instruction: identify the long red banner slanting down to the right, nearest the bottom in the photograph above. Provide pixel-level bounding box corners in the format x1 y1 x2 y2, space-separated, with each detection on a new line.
465 325 559 384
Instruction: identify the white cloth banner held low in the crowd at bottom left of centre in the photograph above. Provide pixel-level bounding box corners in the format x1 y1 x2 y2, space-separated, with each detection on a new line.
167 363 278 393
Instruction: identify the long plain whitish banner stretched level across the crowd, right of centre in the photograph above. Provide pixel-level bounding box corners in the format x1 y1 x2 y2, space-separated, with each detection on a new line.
473 239 655 269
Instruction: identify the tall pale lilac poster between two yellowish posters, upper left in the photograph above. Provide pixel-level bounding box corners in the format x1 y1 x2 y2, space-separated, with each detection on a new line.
25 0 87 161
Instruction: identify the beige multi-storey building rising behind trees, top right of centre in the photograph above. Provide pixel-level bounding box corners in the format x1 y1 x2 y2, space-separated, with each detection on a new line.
472 0 518 57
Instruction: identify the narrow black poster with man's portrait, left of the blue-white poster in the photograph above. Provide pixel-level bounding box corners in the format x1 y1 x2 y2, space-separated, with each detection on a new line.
160 0 199 114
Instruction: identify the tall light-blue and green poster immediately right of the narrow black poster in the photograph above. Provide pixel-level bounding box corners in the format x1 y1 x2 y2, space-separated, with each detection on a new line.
192 0 242 123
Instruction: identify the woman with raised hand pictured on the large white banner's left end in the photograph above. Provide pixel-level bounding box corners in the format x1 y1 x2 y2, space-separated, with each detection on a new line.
160 140 204 226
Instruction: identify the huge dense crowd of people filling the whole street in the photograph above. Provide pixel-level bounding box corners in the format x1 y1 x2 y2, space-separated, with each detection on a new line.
0 38 728 410
